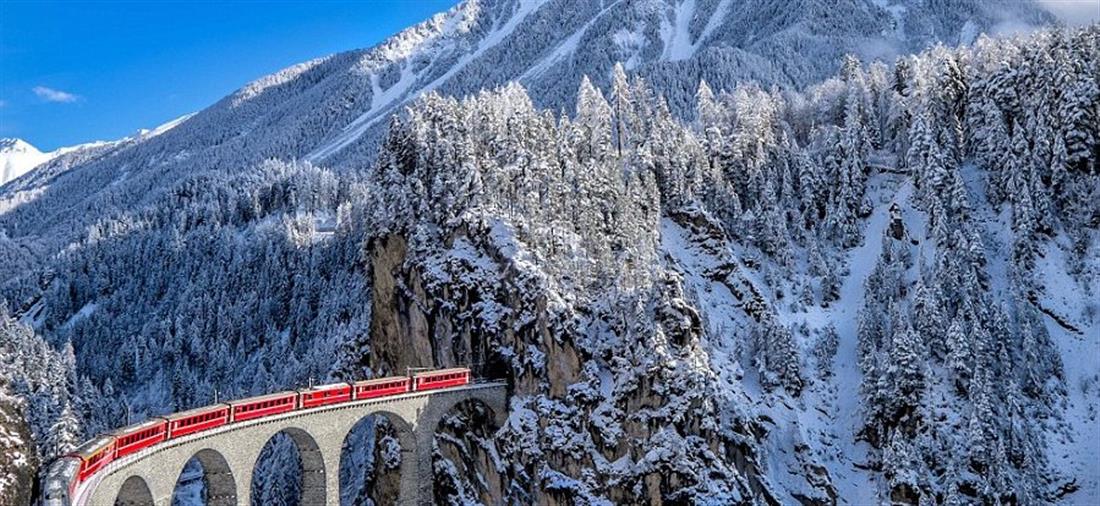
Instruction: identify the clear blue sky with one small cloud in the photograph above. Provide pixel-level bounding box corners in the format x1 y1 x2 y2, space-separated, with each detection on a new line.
0 0 458 151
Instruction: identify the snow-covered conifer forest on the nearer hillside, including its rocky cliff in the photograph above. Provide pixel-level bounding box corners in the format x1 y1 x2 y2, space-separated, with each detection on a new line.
0 16 1100 505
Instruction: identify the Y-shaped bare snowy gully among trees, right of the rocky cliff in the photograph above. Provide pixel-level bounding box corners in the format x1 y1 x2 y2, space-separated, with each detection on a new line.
661 175 923 505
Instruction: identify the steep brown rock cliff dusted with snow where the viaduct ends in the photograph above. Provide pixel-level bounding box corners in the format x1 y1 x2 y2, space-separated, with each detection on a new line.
367 218 796 505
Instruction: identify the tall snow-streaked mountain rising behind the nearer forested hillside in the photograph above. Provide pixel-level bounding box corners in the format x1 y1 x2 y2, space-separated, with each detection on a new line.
0 0 1052 265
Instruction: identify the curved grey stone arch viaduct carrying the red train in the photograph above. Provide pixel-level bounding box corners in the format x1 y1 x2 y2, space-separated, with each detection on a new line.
74 383 507 506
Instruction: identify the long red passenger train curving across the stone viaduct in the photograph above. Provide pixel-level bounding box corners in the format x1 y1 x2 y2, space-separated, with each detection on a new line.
44 367 470 505
